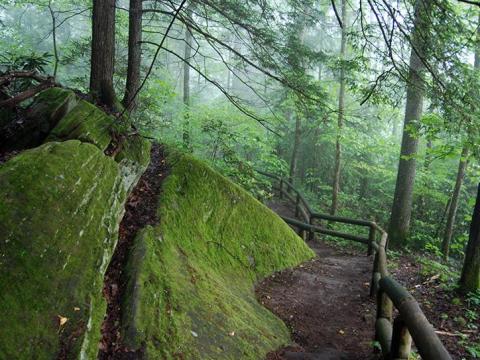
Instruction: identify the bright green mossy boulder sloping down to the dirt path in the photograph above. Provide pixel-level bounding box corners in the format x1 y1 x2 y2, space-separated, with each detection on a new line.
122 154 314 359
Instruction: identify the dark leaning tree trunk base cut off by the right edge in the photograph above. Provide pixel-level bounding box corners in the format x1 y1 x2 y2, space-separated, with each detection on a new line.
460 184 480 293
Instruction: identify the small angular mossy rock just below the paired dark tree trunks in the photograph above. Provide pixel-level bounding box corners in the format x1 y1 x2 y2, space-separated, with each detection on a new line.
47 100 115 151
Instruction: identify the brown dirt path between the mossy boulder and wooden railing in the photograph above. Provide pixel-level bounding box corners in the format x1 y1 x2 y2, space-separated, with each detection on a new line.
256 241 376 360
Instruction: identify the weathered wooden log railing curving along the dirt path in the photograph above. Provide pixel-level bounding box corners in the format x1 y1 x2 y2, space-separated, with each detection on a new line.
257 170 452 360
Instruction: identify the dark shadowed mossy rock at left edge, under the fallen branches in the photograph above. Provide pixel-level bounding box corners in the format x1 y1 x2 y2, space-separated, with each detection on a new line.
0 88 79 151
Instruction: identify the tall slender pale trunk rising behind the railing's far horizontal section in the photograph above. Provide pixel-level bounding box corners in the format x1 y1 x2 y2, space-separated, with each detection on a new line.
330 0 347 215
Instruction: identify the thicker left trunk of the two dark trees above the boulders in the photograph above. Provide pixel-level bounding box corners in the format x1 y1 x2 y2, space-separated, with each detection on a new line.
90 0 115 107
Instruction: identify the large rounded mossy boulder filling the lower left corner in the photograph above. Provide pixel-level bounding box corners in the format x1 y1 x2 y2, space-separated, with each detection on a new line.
0 140 126 359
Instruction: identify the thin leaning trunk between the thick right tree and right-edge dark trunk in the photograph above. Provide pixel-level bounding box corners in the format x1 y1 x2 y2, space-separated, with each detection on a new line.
442 146 468 260
